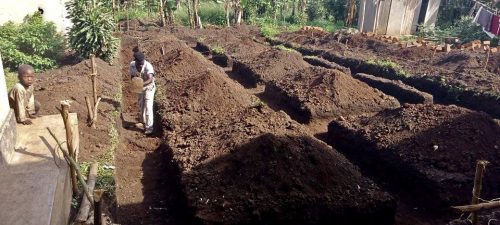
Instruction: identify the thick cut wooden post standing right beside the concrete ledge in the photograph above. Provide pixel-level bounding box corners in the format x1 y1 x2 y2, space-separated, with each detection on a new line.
61 101 79 195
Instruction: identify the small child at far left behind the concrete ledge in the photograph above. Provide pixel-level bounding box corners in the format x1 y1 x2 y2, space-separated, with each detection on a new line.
9 64 40 125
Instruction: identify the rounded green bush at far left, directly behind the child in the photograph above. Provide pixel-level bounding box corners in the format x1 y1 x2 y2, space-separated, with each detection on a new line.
0 13 65 71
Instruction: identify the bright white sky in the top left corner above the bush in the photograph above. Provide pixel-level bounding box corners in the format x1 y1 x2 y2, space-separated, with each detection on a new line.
0 0 71 32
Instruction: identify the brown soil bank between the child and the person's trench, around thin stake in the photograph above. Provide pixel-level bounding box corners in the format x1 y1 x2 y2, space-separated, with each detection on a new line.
35 59 121 161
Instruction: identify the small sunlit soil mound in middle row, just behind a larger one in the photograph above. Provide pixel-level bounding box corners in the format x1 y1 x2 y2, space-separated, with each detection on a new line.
233 49 310 87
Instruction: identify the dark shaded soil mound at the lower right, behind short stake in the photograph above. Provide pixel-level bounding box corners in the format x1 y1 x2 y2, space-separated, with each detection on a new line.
328 105 500 207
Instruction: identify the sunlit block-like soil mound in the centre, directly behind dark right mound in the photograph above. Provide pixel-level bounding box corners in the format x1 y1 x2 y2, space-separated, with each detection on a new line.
265 67 399 122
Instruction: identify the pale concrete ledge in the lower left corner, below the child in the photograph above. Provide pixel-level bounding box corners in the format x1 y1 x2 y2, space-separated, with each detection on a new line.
0 113 79 225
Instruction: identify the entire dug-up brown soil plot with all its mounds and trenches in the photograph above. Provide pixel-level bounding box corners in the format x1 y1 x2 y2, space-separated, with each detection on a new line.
35 23 500 225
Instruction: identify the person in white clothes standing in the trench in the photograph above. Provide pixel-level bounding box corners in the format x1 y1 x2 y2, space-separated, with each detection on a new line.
129 51 156 135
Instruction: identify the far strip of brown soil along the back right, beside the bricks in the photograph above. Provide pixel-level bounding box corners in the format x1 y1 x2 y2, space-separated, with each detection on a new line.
279 30 500 93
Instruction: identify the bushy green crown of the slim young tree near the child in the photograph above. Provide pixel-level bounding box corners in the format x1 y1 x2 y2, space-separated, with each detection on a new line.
66 0 118 62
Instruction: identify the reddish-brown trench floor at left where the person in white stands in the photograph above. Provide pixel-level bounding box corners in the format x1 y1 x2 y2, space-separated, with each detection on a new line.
115 36 197 225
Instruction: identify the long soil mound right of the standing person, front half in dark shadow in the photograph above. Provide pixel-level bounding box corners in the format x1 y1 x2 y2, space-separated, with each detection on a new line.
131 32 395 224
